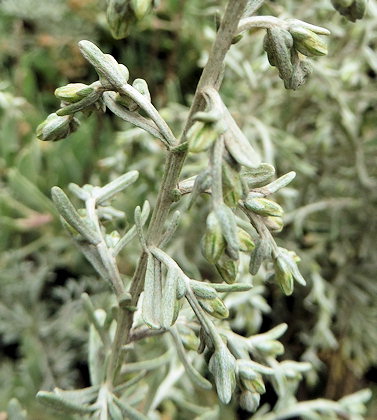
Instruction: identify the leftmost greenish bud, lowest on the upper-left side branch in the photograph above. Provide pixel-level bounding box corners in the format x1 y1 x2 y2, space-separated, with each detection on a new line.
36 113 80 141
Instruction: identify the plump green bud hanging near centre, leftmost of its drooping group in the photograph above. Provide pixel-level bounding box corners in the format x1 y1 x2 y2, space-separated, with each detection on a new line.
201 212 225 264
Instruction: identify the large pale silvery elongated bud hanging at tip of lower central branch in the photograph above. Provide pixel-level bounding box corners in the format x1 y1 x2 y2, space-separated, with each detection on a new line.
208 346 236 404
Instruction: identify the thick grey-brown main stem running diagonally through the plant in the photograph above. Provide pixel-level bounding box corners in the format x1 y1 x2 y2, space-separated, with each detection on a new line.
107 0 248 386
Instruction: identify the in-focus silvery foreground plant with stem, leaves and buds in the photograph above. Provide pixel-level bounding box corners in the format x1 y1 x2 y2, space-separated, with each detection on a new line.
31 0 370 420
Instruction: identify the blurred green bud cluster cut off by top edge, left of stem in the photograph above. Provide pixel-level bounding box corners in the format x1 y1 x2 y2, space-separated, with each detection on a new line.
106 0 156 39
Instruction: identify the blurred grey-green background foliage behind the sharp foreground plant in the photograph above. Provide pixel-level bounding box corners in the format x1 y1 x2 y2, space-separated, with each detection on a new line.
0 0 377 419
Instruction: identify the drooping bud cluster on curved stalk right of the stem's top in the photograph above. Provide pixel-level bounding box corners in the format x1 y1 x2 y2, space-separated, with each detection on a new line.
263 25 327 90
